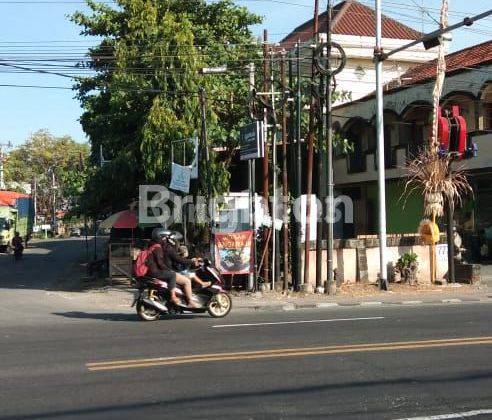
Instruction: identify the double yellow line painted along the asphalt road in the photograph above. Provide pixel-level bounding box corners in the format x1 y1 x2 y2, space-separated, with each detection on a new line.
86 337 492 371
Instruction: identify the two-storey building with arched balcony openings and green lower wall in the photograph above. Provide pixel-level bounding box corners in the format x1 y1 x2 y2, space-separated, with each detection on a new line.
334 41 492 253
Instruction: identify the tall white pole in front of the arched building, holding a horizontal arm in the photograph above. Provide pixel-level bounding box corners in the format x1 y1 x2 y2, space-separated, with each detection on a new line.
374 0 388 290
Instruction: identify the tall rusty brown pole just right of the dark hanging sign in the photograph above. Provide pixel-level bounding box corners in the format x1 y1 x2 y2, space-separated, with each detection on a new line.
263 29 273 283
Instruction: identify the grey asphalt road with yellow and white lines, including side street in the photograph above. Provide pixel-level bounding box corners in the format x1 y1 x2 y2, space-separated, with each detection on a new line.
0 241 492 419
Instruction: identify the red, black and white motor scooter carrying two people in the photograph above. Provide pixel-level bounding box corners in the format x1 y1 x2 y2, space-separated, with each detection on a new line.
132 259 232 321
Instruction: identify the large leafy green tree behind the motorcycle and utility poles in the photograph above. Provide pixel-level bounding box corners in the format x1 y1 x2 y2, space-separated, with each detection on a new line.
72 0 260 213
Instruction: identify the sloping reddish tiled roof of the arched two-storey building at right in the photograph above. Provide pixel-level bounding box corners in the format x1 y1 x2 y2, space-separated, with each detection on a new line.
388 41 492 89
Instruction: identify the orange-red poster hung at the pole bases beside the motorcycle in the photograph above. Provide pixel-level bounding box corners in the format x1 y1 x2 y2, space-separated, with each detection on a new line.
215 230 253 274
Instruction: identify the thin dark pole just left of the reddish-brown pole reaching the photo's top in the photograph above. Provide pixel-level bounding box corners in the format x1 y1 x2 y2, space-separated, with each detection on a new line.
294 39 302 290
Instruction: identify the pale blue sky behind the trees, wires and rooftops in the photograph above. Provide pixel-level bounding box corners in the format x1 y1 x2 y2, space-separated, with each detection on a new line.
0 0 492 145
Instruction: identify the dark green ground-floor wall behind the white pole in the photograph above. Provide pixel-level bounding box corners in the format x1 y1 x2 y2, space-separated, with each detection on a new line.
367 180 424 234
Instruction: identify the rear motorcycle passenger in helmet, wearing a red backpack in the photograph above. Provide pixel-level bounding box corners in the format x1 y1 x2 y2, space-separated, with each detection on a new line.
147 228 201 307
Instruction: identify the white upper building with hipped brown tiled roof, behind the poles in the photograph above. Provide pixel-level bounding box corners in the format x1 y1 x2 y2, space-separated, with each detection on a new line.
280 0 437 100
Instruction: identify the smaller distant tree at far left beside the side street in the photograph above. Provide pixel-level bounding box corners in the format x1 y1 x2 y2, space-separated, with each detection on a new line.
5 130 89 214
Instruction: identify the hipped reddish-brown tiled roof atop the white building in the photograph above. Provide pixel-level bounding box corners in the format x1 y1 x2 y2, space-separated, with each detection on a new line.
281 0 421 49
